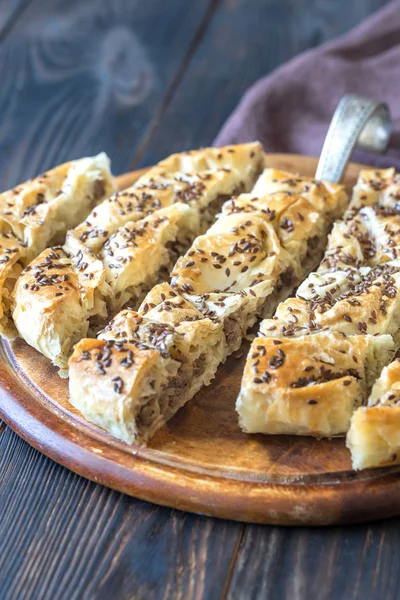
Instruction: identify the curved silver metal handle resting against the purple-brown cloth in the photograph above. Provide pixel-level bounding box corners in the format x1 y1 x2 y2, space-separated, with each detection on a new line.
315 94 392 183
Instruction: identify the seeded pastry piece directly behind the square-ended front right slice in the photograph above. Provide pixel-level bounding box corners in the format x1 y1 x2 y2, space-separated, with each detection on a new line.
260 261 400 342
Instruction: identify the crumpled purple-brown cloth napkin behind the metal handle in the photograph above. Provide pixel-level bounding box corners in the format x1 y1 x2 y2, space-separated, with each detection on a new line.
214 0 400 168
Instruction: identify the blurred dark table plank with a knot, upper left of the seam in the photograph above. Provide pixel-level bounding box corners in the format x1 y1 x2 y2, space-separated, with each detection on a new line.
0 0 214 188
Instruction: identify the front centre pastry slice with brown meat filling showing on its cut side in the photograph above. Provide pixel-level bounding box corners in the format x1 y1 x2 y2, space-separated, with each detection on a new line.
69 283 225 444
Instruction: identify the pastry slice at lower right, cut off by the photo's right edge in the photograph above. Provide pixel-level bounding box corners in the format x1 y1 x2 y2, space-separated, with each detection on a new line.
346 358 400 469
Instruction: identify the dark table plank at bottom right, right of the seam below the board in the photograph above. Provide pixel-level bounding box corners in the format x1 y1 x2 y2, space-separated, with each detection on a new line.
226 516 400 600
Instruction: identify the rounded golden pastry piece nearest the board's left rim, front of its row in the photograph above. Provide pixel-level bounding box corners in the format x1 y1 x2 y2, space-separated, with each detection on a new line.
13 247 111 375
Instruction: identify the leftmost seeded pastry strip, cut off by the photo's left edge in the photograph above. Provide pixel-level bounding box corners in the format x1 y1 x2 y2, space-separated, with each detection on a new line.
0 153 115 337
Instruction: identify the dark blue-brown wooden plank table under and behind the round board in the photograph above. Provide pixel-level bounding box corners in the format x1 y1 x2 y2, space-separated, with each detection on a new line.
0 0 400 600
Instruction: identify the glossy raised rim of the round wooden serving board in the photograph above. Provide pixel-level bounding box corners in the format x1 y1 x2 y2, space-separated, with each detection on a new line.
0 154 400 526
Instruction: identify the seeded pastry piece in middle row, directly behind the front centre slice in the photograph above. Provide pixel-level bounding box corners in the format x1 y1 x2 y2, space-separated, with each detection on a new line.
171 169 347 352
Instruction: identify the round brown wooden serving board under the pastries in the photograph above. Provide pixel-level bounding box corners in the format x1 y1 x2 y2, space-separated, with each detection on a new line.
0 155 400 525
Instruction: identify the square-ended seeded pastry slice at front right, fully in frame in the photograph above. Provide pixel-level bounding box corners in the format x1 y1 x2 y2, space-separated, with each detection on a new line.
236 331 394 437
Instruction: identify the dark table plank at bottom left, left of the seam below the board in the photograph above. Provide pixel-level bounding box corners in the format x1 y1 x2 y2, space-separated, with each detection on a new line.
0 430 240 600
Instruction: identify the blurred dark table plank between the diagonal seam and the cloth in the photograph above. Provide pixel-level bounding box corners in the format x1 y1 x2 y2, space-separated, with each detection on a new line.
134 0 385 167
